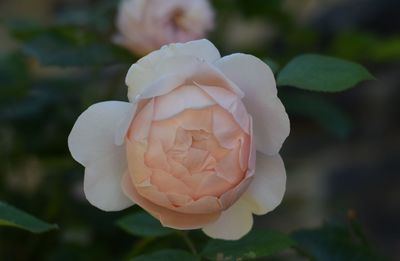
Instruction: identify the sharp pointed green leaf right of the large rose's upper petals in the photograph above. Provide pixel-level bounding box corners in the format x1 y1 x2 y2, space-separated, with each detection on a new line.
277 54 374 92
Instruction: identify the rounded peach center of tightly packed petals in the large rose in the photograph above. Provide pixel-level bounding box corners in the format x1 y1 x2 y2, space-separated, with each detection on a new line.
127 84 250 214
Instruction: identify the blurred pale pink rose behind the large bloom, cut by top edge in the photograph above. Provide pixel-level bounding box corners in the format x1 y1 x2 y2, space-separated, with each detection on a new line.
115 0 214 55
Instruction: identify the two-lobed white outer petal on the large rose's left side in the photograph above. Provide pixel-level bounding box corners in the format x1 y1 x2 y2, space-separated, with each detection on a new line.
68 101 133 211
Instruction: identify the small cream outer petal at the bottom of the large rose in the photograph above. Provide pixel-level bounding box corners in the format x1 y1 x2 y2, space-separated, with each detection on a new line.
203 199 253 240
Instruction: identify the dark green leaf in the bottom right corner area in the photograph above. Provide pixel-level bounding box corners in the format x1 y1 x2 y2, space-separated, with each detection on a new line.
293 221 384 261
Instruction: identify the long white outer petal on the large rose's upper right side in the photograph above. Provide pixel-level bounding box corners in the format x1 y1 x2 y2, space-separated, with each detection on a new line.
215 54 290 155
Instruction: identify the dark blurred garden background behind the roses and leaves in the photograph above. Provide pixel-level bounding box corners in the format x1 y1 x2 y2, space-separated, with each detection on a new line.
0 0 400 260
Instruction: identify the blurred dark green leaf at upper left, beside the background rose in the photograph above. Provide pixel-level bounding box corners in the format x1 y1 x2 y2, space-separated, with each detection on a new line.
11 23 135 67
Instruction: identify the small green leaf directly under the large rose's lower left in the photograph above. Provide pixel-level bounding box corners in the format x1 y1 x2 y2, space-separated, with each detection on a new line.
117 212 175 237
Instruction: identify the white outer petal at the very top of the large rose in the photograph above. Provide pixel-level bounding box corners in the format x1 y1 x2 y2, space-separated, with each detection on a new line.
125 39 221 101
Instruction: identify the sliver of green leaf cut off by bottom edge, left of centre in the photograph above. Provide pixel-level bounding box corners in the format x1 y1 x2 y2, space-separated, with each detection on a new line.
131 249 200 261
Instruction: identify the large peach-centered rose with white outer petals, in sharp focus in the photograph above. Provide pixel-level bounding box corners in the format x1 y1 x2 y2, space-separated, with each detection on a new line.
68 40 289 239
